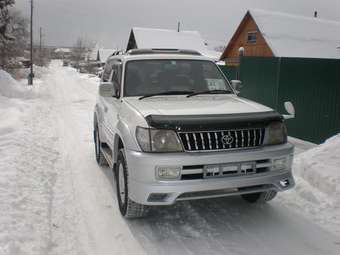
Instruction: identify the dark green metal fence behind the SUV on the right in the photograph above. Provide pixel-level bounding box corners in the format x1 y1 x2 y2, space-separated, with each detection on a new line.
220 57 340 143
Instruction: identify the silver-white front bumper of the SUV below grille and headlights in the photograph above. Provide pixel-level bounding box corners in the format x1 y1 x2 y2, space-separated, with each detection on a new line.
125 143 295 205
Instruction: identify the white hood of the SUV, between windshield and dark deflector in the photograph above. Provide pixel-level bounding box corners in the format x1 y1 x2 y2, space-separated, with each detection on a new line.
123 95 272 117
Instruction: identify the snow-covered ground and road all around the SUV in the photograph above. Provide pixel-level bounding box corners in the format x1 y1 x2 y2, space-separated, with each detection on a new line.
0 62 340 255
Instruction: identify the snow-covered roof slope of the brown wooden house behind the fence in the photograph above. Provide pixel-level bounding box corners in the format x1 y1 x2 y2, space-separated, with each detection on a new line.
249 9 340 58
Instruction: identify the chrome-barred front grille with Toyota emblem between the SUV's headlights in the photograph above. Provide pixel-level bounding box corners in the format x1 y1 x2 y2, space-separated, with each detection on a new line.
179 128 265 151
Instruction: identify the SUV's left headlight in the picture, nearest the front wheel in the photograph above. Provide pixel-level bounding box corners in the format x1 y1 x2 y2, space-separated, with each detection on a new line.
136 127 183 152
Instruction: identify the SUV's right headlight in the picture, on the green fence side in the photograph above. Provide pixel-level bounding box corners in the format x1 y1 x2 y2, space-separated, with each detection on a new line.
263 121 287 145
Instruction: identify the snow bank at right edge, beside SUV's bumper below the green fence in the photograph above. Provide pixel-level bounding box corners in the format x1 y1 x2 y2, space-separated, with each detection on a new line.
278 134 340 235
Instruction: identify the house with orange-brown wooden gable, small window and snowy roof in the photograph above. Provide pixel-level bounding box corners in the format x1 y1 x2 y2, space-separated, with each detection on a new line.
221 10 340 64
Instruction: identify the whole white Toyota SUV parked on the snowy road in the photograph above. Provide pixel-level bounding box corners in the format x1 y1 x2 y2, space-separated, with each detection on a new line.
94 50 294 218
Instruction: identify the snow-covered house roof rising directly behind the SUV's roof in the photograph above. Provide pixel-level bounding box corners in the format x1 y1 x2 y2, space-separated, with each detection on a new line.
127 27 220 60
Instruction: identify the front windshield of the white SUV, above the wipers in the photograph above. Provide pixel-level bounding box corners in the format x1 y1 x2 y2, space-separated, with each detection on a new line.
124 59 232 96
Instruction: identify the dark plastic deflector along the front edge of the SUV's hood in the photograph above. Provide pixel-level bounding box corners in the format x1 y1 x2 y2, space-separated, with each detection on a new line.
145 111 283 131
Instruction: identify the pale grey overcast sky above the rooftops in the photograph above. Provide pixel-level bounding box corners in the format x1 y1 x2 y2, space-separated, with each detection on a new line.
16 0 340 48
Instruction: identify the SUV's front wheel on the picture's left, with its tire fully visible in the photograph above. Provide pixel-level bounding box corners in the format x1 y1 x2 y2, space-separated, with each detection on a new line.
115 149 148 219
